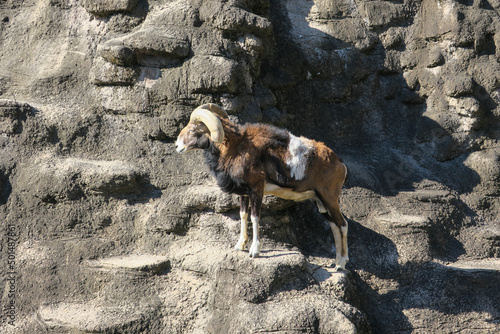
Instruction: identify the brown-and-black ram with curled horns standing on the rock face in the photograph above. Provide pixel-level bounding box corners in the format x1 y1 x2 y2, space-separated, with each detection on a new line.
175 103 349 270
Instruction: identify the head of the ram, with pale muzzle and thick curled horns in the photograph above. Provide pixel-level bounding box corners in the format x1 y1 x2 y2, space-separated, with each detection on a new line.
175 103 228 153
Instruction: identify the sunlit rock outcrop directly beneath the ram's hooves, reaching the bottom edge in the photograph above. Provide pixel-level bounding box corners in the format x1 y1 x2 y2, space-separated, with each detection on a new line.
207 252 370 333
